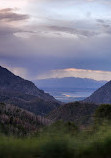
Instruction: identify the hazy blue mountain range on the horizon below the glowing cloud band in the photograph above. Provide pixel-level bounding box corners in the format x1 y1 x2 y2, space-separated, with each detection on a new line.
34 77 106 88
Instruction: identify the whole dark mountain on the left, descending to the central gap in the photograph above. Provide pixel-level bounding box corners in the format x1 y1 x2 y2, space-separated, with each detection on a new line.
0 67 60 115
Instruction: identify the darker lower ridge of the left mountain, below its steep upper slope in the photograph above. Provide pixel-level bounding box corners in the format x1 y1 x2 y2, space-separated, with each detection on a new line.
0 90 59 116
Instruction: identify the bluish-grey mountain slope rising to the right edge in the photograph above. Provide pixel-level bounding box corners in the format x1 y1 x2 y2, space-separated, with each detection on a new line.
84 81 111 104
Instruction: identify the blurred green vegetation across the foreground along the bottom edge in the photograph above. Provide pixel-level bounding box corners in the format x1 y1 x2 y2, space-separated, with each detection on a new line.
0 105 111 158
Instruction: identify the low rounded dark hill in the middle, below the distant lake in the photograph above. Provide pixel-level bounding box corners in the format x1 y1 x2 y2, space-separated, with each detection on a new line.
48 102 98 125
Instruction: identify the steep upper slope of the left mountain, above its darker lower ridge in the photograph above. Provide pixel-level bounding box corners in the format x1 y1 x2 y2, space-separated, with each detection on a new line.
0 66 55 100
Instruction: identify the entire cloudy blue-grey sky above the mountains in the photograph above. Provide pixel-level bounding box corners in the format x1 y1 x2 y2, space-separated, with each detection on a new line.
0 0 111 81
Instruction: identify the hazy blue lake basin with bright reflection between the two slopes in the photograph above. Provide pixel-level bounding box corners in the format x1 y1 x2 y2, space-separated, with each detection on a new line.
39 87 96 103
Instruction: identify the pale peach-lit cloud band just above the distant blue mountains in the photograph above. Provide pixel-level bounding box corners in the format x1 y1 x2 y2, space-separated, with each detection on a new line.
36 68 111 81
